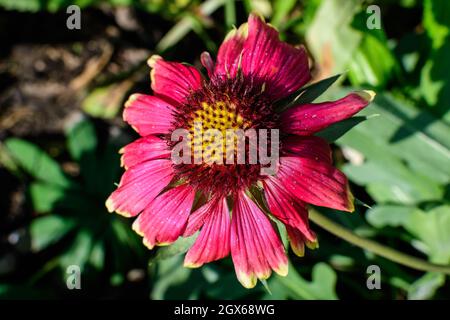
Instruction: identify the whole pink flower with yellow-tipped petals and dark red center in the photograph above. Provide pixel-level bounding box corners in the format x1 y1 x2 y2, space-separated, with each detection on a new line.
106 15 373 288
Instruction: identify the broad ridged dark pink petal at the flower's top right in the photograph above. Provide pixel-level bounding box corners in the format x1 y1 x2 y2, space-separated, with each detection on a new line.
242 14 311 99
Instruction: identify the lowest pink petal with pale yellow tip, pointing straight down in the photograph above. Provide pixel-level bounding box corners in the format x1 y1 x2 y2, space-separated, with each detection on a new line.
231 192 288 288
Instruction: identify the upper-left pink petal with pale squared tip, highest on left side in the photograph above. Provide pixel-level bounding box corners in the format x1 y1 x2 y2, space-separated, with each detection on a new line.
148 55 202 105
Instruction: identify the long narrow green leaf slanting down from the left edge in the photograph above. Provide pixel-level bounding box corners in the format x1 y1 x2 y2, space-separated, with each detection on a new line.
5 138 72 187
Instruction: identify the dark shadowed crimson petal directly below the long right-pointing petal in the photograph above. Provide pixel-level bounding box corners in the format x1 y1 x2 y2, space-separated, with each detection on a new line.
283 136 332 164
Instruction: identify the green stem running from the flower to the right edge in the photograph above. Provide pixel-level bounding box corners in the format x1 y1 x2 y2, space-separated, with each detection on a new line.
309 209 450 275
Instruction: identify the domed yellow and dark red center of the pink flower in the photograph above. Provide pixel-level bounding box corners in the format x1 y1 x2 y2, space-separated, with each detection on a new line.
168 75 278 195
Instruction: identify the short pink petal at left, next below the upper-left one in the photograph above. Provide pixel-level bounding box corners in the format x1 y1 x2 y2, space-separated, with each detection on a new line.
123 94 174 136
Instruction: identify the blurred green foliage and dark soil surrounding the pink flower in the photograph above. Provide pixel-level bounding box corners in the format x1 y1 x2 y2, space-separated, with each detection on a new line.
0 0 450 299
